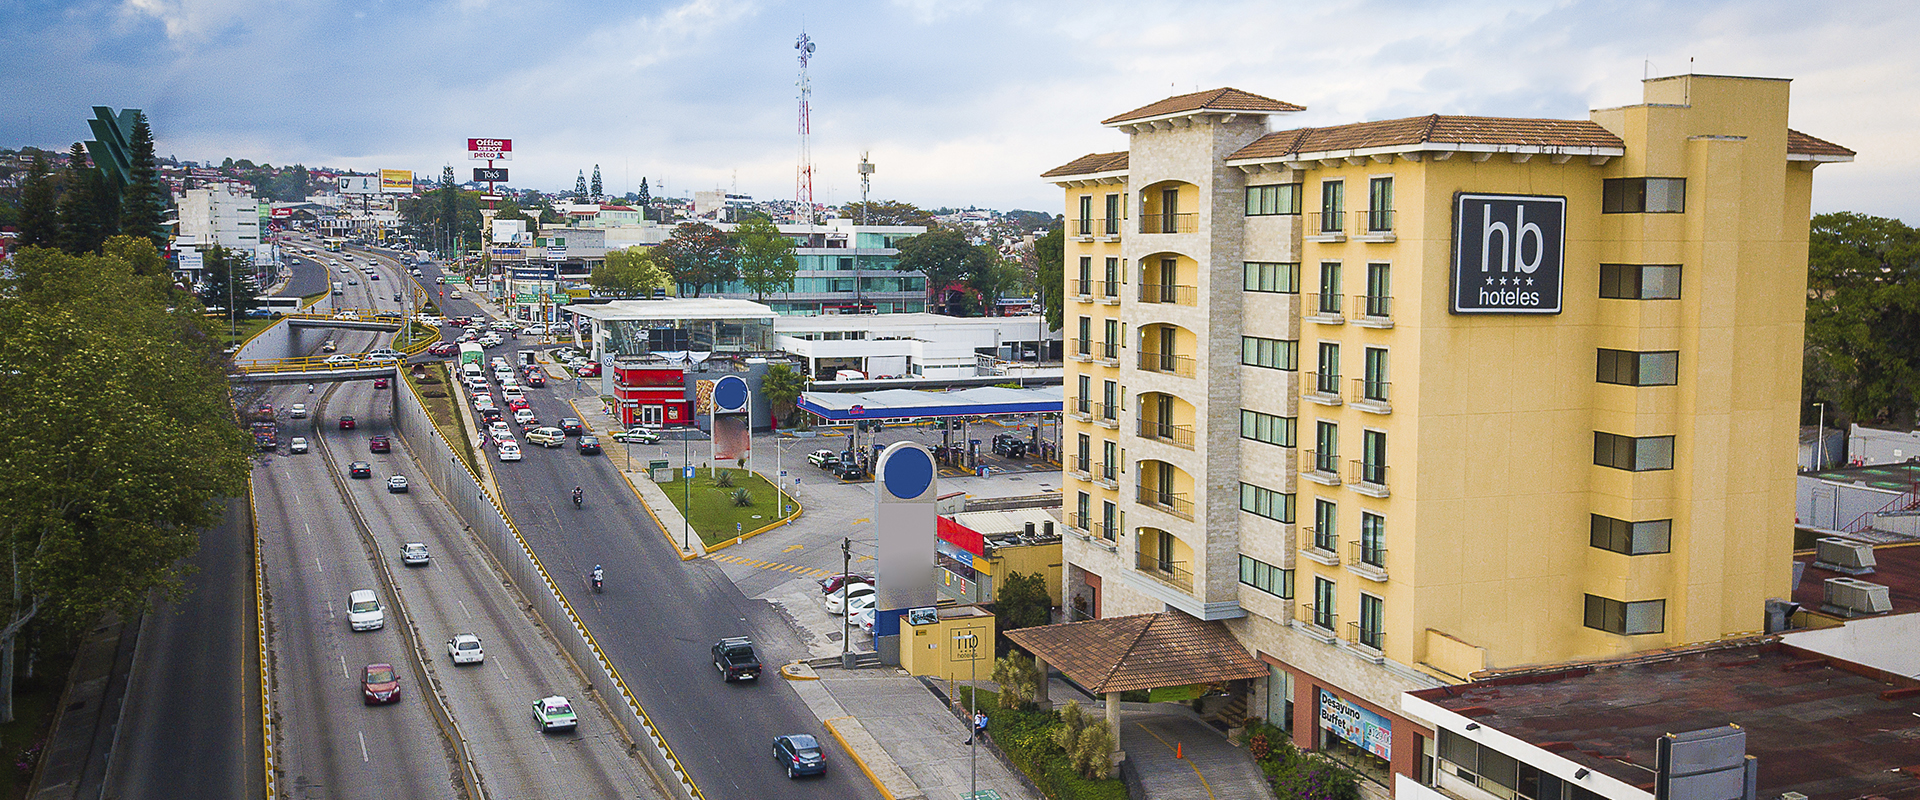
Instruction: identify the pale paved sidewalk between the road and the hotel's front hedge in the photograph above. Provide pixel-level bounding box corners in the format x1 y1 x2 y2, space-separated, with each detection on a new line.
793 670 1039 800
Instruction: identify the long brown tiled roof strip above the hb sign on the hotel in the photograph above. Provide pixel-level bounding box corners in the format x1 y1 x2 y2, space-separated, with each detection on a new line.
1227 113 1626 159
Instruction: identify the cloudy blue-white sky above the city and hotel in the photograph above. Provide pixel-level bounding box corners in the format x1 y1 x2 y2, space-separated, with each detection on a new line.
0 0 1920 223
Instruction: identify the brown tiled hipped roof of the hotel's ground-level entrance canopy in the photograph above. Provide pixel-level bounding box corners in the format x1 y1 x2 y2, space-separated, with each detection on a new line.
1006 612 1267 694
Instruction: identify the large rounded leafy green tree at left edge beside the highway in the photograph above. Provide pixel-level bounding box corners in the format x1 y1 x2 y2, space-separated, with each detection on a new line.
0 238 252 716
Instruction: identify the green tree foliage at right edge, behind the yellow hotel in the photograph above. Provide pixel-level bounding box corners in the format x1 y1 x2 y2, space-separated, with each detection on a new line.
1801 211 1920 430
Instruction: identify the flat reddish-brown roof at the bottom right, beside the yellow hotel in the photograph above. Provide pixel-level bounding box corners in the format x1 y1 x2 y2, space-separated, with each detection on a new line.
1411 641 1920 800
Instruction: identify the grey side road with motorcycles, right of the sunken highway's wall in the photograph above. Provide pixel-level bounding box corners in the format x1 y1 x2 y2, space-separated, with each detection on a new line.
422 257 879 800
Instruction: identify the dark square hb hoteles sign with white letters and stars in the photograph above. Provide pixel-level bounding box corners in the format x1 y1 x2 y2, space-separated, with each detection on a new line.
1452 194 1567 315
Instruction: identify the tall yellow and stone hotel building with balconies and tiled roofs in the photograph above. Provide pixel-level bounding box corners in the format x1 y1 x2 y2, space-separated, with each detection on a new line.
1043 75 1853 785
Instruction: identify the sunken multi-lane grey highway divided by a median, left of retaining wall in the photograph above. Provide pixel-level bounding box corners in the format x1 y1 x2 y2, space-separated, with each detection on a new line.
255 241 659 798
